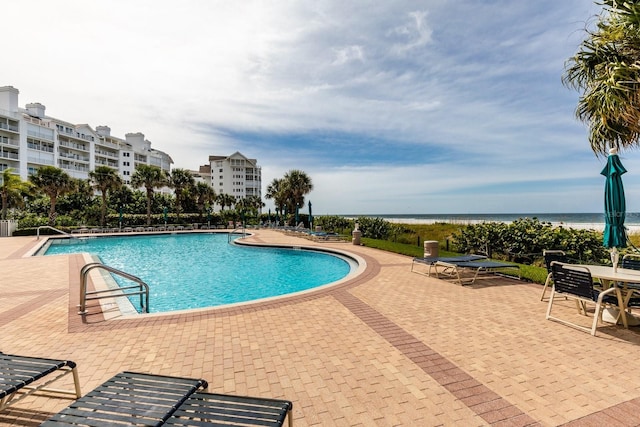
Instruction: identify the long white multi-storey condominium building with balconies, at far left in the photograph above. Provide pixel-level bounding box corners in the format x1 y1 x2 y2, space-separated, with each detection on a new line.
0 86 173 184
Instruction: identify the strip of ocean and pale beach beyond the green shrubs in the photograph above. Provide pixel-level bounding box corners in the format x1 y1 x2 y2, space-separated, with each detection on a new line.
343 212 640 231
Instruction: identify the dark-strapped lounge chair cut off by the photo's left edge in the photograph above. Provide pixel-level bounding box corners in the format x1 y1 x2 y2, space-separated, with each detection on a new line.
0 352 81 411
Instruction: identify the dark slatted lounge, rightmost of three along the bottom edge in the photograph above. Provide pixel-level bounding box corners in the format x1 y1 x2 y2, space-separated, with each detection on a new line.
165 392 293 427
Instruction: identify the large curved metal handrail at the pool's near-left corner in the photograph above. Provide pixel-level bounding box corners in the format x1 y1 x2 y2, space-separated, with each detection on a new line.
78 262 149 314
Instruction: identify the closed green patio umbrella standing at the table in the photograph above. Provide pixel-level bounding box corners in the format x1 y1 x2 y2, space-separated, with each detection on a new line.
600 148 627 269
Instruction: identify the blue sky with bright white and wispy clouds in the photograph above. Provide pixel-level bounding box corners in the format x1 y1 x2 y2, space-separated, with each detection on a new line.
0 0 640 215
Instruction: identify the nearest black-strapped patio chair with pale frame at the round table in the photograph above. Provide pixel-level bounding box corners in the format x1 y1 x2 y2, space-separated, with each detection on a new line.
546 261 622 336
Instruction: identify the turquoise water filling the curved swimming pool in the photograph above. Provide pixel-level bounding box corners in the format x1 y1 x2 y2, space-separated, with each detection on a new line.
45 233 351 313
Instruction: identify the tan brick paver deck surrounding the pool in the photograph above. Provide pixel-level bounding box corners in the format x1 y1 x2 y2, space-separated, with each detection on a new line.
0 230 640 426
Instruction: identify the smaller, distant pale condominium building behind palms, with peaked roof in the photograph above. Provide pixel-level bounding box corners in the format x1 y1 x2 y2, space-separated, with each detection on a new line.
198 151 262 212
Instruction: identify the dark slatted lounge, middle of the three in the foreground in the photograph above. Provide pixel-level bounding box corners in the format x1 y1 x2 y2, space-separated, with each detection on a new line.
41 372 208 427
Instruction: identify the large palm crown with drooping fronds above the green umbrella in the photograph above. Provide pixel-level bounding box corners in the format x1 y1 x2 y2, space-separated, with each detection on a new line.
562 0 640 155
